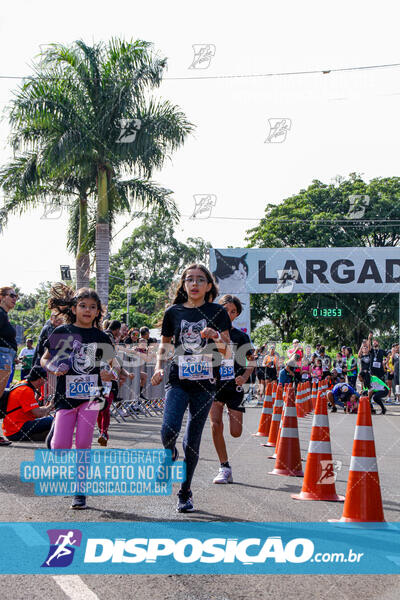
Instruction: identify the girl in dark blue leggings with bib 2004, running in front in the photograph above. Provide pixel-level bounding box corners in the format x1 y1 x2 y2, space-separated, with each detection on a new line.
151 264 231 512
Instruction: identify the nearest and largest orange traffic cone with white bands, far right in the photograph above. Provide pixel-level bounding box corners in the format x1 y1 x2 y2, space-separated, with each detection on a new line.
330 396 385 523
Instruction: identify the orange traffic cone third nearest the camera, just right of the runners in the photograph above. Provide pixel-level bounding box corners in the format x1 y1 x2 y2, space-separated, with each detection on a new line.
271 388 303 477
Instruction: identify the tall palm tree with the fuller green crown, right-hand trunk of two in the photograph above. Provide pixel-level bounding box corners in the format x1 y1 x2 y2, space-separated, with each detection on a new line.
0 39 193 305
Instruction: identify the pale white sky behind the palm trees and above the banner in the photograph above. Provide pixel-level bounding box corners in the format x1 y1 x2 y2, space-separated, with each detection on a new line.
0 0 400 292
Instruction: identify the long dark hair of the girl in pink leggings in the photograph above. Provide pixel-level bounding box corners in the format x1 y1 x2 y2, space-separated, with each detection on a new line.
47 283 103 329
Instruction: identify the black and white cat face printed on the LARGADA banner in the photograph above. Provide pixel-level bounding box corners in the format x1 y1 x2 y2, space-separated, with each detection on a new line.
213 250 249 294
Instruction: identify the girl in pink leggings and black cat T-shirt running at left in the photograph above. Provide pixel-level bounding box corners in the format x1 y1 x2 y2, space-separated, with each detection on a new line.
40 284 115 509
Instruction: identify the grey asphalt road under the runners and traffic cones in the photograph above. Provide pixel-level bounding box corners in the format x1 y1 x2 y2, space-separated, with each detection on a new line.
0 406 400 600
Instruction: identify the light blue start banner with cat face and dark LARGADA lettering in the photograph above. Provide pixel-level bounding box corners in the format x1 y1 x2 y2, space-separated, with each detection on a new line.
210 247 400 294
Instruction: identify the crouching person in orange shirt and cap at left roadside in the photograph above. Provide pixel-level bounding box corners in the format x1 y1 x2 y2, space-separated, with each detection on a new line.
3 366 53 442
